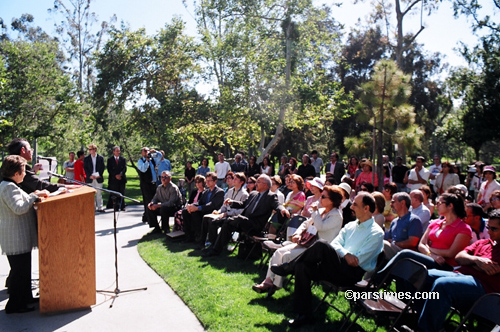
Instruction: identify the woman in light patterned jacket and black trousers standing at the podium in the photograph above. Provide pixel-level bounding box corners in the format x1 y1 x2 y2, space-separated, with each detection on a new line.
0 155 48 314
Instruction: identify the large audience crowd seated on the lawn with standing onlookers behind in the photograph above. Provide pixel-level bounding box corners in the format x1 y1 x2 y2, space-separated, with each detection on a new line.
150 151 500 331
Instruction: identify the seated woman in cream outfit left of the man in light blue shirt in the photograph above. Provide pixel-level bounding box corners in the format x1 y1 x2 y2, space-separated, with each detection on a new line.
252 186 344 295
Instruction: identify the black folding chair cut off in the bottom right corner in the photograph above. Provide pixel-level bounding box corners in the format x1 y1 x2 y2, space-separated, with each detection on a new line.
455 293 500 332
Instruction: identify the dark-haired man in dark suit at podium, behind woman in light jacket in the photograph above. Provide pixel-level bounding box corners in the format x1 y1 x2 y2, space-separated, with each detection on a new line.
7 138 65 194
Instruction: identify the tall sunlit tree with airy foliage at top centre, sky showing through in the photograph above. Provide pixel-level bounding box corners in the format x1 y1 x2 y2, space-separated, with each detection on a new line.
197 0 343 160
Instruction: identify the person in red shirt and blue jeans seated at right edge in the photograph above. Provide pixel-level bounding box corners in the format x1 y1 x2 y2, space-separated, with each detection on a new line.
418 210 500 332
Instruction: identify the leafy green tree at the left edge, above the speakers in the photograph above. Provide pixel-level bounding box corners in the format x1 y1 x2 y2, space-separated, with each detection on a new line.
0 28 76 150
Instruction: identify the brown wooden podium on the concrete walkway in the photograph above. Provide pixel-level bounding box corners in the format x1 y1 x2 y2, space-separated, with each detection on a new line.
37 187 96 313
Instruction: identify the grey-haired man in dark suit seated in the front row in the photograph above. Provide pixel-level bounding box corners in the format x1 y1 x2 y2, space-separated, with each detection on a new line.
204 174 290 257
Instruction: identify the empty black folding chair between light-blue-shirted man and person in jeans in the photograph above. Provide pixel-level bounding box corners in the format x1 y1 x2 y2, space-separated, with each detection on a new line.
345 258 427 331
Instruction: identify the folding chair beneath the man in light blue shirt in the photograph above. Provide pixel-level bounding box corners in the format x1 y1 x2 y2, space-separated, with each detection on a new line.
314 251 386 322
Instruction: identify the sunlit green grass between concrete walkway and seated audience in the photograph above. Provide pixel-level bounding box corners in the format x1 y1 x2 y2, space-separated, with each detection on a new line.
138 234 385 331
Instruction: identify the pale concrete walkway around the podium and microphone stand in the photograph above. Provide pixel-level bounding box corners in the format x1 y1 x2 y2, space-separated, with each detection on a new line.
0 205 204 332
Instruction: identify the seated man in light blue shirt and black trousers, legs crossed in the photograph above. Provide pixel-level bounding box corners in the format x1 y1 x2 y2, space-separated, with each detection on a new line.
271 192 384 327
